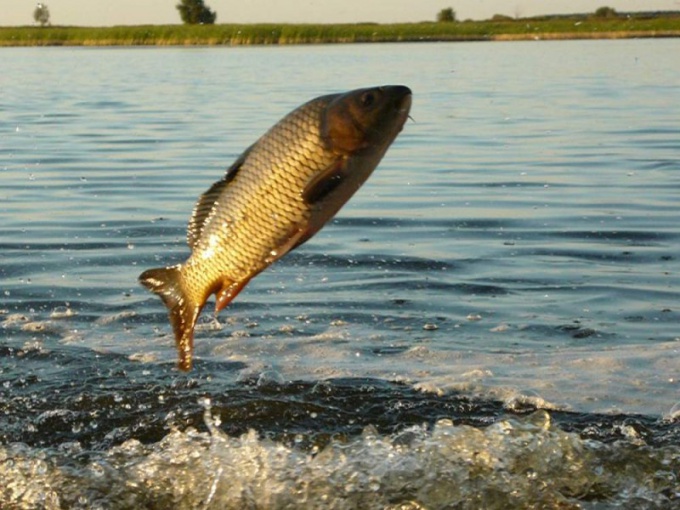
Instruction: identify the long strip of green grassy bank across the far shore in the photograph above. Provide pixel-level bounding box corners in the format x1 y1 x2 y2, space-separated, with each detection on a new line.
0 13 680 46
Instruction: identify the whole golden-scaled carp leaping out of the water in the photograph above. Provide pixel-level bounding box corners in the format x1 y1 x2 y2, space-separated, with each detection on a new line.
139 85 411 370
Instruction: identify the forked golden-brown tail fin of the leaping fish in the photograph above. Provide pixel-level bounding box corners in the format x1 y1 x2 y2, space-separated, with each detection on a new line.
139 266 203 372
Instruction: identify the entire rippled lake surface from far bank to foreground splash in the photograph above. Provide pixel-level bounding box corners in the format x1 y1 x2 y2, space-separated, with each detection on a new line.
0 39 680 509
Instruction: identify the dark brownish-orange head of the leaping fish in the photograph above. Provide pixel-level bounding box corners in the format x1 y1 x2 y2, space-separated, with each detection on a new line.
321 85 411 154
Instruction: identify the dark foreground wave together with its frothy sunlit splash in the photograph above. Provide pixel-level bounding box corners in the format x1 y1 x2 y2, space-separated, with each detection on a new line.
0 347 680 510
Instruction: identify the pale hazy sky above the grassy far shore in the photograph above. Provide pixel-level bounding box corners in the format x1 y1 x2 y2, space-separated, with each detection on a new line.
0 0 680 26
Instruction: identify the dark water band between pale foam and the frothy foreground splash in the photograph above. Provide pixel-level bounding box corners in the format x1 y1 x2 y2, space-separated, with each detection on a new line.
0 345 680 449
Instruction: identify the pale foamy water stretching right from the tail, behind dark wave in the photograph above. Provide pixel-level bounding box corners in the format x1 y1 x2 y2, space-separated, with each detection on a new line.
202 325 680 416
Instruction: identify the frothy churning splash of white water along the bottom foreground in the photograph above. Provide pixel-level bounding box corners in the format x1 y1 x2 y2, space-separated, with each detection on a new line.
0 408 680 510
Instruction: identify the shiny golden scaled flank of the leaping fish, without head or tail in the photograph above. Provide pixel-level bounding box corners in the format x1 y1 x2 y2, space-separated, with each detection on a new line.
182 101 337 294
